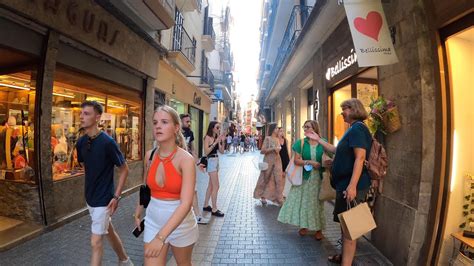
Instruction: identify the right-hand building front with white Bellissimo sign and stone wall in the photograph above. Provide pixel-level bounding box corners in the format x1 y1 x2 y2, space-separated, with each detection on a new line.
260 0 474 265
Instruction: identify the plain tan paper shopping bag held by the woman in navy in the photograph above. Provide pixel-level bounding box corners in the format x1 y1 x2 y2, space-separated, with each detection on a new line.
338 202 377 240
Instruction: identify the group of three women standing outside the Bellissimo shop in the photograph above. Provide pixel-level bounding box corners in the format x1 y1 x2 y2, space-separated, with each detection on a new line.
253 99 372 265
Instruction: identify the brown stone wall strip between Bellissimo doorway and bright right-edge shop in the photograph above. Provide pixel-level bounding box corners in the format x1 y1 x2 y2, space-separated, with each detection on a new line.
372 0 440 265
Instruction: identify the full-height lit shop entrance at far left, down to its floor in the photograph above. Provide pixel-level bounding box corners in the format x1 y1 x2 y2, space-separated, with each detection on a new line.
0 47 42 251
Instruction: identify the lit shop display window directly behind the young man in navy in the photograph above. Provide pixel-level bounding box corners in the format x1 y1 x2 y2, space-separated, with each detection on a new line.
51 68 142 180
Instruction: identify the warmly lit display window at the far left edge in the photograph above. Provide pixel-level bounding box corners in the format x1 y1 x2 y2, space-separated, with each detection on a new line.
0 70 36 183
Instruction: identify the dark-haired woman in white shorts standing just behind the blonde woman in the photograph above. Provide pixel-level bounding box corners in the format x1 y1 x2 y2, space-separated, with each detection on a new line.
202 121 225 217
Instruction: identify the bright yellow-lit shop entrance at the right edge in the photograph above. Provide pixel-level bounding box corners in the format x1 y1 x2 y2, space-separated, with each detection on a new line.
438 20 474 265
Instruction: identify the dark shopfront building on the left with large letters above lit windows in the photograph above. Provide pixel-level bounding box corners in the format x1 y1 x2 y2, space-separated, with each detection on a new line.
0 0 174 250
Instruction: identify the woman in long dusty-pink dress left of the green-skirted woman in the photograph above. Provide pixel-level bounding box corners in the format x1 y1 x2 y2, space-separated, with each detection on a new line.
253 123 285 205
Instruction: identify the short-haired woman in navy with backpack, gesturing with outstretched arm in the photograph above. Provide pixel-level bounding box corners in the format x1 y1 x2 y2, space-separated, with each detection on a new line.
305 98 372 265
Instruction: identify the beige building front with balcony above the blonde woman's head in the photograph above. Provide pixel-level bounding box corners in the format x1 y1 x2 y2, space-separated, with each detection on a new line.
155 0 215 156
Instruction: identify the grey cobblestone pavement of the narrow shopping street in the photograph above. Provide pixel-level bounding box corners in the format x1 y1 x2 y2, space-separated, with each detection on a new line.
0 153 390 265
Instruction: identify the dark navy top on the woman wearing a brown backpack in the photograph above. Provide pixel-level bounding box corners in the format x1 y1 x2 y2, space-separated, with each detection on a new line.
331 122 372 191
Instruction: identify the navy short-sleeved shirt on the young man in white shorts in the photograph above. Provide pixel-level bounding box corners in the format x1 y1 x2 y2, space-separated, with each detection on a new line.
76 132 125 207
